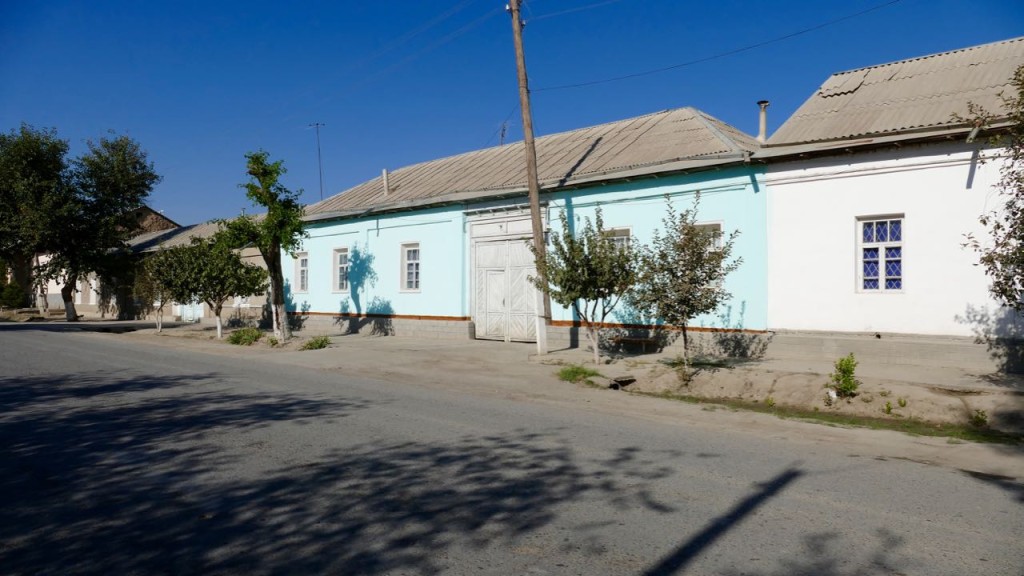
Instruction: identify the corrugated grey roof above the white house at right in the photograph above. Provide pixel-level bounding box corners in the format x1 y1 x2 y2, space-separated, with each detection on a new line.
759 37 1024 146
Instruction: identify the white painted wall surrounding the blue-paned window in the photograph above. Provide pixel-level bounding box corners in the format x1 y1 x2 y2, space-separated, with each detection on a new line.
766 143 1015 336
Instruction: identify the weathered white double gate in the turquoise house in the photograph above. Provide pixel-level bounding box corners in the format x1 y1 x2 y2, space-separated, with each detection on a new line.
473 239 537 342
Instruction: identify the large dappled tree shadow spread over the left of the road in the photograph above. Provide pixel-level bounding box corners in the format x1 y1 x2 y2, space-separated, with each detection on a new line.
0 375 692 575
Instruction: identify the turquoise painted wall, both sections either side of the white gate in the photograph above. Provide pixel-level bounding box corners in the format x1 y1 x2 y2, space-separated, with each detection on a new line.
285 163 767 330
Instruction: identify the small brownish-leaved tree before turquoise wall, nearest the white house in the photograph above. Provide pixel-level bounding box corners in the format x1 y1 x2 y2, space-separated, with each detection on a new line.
629 193 742 363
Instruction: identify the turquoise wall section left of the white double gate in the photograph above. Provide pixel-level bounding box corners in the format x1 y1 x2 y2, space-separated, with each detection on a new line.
284 202 469 317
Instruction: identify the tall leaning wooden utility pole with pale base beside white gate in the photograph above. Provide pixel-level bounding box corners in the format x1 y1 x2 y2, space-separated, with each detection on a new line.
509 0 551 354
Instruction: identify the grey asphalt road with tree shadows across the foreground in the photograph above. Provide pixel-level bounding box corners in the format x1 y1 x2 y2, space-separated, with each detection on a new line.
0 325 1024 576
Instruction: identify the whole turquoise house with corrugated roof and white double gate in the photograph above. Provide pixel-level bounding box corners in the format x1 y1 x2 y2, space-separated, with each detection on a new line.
285 108 767 341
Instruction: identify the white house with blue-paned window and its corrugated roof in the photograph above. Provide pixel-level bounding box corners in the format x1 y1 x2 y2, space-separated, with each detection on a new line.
755 38 1024 336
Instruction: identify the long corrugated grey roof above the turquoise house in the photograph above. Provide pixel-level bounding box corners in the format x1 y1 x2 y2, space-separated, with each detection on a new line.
306 108 758 219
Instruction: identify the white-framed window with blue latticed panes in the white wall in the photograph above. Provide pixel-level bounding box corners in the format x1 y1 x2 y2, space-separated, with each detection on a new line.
857 215 903 292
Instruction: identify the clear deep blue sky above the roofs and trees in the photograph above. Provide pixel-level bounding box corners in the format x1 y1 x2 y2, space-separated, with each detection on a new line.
0 0 1024 223
